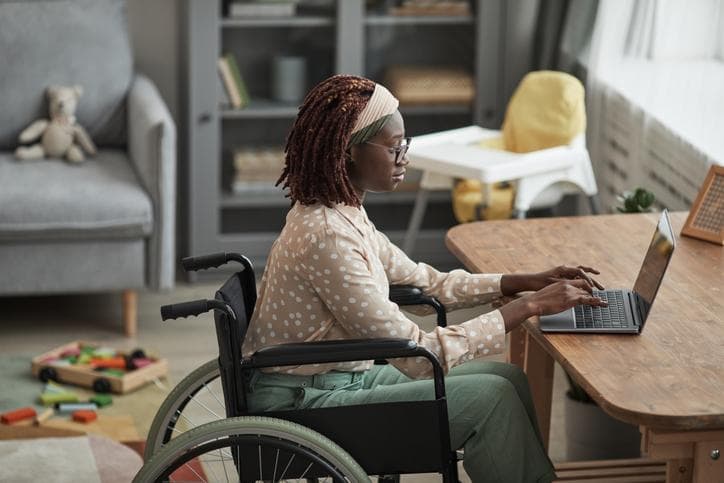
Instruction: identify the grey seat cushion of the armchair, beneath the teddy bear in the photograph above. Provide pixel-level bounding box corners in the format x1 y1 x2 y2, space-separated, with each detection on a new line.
0 150 153 241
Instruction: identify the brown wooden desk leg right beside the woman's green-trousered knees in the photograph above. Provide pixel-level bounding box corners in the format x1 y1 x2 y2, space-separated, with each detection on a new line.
525 332 553 451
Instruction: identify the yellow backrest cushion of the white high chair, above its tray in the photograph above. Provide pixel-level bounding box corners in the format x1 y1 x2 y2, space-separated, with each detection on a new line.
502 70 586 153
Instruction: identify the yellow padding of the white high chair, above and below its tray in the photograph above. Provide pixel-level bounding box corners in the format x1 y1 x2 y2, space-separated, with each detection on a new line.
452 71 586 223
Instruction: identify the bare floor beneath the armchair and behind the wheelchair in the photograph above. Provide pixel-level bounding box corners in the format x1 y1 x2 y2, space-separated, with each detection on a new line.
0 282 566 483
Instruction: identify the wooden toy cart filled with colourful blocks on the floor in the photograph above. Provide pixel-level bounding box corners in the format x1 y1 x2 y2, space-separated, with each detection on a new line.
32 341 168 396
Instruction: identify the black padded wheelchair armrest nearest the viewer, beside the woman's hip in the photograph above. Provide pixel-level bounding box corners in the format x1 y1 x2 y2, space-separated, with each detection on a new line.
249 338 445 399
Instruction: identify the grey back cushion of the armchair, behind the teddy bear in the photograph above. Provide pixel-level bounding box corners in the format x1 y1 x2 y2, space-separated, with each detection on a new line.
0 0 133 150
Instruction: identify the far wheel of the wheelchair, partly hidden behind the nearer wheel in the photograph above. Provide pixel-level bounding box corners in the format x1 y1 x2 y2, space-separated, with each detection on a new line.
144 359 226 461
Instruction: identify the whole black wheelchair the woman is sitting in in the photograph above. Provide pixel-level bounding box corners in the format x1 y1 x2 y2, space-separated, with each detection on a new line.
134 253 461 483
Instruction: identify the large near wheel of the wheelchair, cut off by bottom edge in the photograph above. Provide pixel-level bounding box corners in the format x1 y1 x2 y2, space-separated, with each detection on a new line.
133 416 370 483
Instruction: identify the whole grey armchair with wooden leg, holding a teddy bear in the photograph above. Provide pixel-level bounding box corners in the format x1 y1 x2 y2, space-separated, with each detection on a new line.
0 0 176 335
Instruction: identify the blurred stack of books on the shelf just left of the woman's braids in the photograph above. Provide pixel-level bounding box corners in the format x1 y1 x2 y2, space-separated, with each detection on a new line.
231 147 284 193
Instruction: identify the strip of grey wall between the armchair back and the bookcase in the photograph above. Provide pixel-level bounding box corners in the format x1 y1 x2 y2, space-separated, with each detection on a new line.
128 0 179 122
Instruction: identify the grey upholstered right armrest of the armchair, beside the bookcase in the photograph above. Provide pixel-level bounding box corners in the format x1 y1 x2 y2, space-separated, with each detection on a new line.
127 75 176 289
